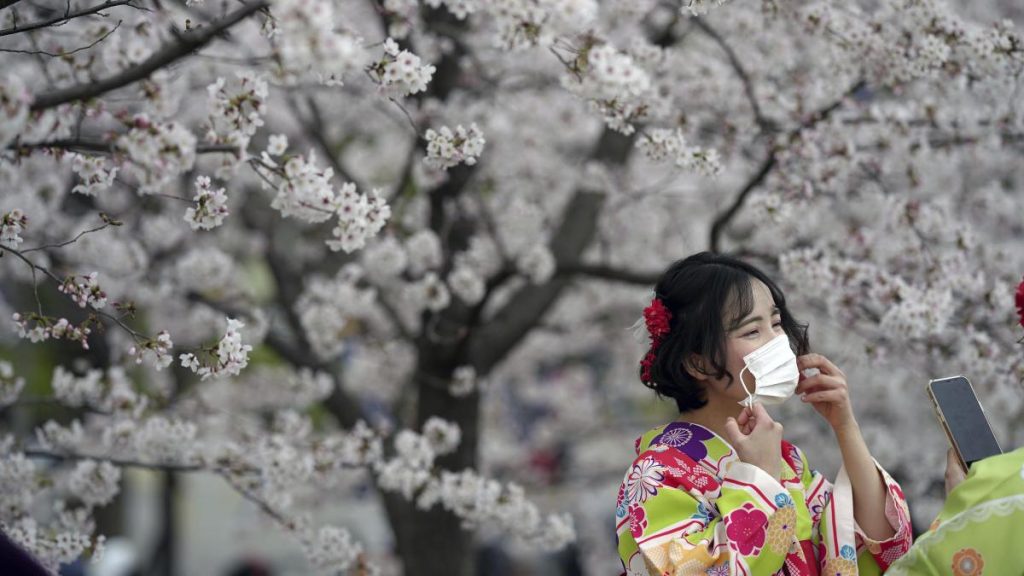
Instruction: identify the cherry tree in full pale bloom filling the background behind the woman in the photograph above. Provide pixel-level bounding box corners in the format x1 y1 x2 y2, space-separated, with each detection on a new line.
0 0 1024 575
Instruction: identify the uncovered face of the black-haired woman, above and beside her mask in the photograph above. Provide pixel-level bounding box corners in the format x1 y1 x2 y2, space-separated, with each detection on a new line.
706 279 783 402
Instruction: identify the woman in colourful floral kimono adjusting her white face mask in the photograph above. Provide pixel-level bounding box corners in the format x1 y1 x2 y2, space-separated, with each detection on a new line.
616 253 911 576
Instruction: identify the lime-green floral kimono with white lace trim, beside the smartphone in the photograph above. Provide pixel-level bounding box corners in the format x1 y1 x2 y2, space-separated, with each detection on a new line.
889 448 1024 576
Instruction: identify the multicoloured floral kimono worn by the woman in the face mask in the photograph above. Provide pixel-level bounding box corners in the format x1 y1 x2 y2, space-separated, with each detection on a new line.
615 421 912 576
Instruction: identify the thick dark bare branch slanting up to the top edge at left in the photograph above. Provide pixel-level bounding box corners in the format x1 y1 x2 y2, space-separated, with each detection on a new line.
31 0 268 112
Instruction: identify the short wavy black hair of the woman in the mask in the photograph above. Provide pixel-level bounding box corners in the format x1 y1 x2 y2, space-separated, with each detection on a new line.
641 252 809 412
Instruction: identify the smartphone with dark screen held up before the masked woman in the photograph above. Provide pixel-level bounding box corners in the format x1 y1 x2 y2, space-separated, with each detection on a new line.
928 376 1002 472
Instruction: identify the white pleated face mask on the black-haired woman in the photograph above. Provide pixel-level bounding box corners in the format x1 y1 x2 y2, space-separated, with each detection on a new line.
739 334 800 407
